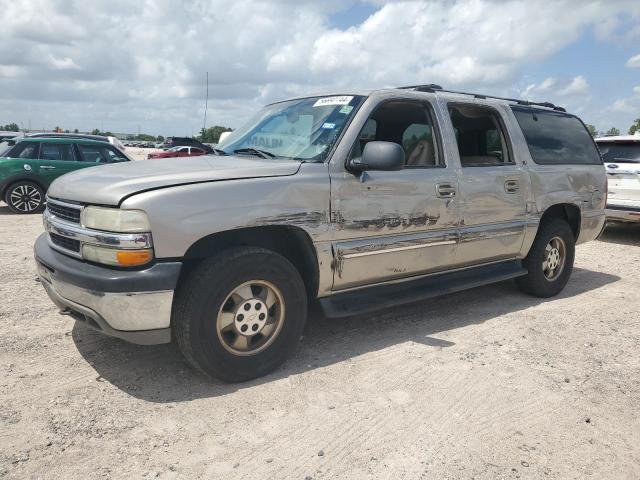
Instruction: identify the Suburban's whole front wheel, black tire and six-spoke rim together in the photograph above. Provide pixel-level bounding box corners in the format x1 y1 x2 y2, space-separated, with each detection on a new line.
173 247 307 382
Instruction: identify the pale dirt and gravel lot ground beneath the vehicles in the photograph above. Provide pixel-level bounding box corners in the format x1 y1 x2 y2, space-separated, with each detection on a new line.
0 210 640 480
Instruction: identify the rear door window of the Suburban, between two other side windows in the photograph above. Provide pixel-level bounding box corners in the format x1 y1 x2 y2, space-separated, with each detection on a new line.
449 105 513 167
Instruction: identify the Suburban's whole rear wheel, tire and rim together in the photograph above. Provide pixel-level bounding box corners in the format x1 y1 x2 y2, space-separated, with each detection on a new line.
516 218 575 298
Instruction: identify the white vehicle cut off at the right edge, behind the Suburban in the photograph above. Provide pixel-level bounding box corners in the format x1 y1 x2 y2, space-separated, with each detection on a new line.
596 132 640 222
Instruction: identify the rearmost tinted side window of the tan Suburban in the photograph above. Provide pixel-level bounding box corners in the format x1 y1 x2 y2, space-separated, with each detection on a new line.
511 106 602 165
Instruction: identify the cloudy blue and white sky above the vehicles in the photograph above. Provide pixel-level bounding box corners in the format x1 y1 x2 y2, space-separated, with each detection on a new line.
0 0 640 136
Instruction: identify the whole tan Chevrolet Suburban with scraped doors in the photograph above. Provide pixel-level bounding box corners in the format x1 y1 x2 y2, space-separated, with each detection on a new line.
35 85 606 381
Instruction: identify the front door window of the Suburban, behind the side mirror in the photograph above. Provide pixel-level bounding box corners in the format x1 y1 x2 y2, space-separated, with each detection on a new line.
351 100 442 168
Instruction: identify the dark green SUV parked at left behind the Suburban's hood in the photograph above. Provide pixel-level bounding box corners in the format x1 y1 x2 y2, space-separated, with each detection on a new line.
0 138 131 213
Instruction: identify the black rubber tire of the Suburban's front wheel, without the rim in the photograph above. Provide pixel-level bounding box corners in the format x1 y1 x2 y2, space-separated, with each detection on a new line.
172 247 307 382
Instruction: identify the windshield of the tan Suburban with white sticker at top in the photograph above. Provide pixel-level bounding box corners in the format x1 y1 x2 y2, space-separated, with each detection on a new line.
217 95 364 162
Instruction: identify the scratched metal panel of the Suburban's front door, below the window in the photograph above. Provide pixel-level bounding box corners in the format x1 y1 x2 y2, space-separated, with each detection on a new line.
331 168 458 290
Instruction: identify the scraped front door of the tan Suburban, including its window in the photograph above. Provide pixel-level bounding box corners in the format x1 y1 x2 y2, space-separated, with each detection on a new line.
331 100 458 290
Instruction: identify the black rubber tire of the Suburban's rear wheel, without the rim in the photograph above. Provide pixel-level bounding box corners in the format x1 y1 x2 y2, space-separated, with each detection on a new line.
516 218 575 298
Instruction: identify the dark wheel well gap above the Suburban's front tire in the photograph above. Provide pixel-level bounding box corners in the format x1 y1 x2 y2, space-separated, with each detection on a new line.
183 225 320 298
